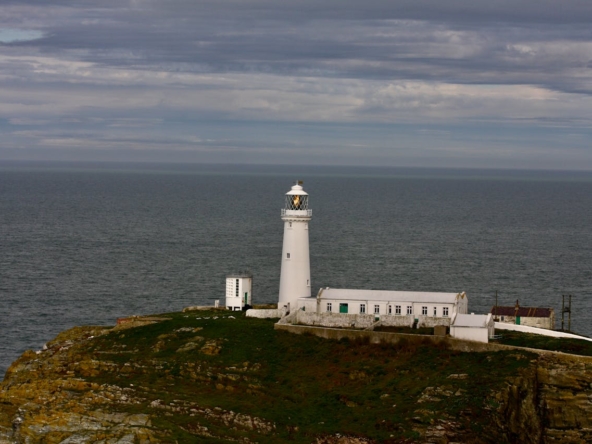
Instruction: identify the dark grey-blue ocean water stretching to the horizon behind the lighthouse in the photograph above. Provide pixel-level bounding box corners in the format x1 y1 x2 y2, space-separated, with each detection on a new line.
0 162 592 375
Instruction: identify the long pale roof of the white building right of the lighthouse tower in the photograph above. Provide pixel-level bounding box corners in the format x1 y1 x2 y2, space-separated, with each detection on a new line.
320 288 466 304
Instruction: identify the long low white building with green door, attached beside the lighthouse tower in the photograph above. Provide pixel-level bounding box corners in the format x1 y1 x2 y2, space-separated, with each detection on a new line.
298 288 468 327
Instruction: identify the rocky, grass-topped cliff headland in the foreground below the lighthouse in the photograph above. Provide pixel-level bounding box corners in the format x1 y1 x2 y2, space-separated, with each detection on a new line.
0 312 592 444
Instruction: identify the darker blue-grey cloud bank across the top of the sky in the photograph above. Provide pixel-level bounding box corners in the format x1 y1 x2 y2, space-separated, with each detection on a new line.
2 1 592 92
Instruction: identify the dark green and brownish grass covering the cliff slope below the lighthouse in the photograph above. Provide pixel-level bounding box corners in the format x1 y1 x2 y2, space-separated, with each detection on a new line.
80 312 532 443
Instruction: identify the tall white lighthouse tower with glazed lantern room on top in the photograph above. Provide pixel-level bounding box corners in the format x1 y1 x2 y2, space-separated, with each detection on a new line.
278 181 312 309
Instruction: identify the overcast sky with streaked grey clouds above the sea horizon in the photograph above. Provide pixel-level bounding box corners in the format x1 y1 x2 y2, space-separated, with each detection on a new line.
0 0 592 170
